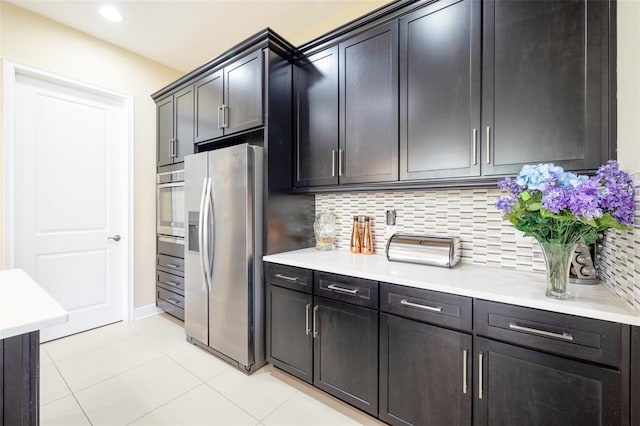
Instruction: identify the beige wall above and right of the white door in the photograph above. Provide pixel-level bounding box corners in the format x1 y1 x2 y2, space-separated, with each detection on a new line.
0 1 182 307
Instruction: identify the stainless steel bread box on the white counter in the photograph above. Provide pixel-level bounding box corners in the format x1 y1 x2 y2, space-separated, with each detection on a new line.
386 234 461 268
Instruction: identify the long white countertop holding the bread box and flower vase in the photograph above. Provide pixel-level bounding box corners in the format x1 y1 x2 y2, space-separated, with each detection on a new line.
263 248 640 325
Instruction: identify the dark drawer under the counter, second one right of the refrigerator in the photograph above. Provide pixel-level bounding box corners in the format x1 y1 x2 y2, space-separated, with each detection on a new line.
313 271 378 309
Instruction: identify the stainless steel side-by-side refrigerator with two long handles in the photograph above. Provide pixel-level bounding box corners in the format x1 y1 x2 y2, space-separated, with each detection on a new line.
184 143 265 373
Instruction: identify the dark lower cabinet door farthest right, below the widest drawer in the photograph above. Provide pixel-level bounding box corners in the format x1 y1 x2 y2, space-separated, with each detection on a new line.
474 338 625 426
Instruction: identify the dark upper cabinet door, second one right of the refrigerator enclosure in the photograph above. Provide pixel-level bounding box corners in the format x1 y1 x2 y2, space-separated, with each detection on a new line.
338 22 398 183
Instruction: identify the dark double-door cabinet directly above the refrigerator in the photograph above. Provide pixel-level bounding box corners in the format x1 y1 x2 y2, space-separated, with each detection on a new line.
194 51 263 143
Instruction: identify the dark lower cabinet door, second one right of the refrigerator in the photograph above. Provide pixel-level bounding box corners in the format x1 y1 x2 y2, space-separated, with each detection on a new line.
313 297 378 416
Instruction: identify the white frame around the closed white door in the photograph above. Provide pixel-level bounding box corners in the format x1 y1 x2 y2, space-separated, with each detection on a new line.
0 59 134 321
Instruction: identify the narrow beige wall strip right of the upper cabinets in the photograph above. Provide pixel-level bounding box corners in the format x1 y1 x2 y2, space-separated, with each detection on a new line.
617 0 640 173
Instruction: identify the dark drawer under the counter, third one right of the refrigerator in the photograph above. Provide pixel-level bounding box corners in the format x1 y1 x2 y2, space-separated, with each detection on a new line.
380 283 473 331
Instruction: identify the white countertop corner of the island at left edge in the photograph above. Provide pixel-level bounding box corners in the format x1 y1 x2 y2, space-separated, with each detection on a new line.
0 269 68 339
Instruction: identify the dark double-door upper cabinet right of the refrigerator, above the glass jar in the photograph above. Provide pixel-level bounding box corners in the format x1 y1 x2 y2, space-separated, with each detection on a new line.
295 22 398 187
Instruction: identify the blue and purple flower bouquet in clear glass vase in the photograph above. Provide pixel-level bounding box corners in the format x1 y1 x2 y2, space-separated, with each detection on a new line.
496 161 635 299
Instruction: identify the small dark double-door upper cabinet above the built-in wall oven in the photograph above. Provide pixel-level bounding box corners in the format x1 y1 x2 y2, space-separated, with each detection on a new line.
156 86 194 166
